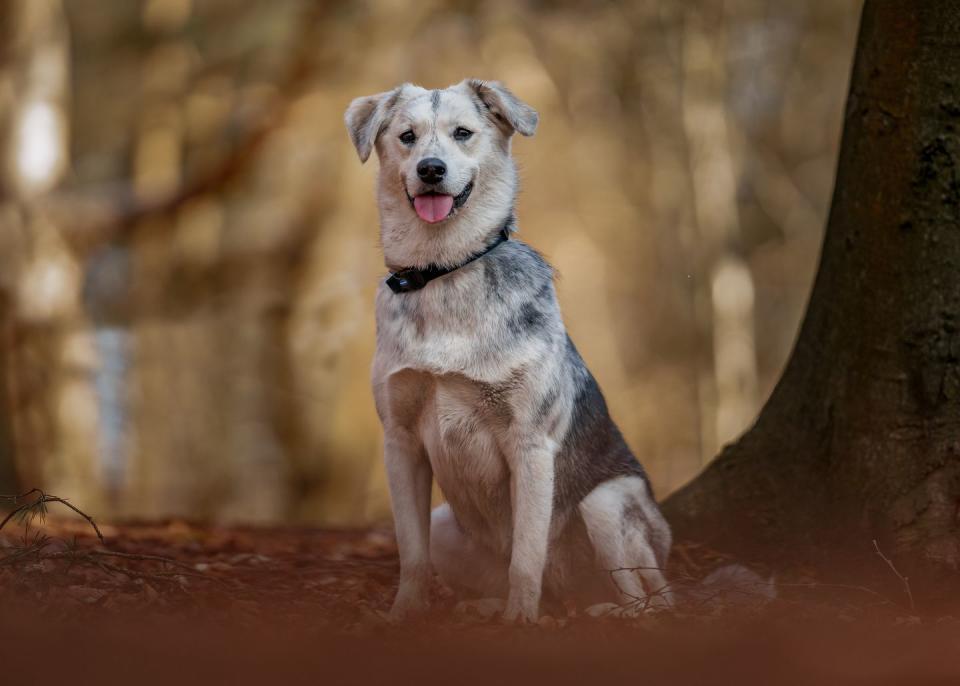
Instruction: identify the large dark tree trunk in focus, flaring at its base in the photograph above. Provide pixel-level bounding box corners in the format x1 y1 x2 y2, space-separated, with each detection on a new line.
664 0 960 593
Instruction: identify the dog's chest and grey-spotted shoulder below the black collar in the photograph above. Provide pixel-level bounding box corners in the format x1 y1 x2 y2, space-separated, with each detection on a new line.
373 241 566 553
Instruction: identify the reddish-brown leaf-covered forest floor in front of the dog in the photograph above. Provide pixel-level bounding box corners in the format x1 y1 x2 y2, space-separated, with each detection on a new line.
0 516 960 684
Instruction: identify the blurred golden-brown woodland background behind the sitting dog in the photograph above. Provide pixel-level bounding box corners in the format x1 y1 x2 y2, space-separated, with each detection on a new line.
0 0 860 525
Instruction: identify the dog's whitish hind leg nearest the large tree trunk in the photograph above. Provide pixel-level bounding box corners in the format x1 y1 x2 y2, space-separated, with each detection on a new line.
580 476 672 608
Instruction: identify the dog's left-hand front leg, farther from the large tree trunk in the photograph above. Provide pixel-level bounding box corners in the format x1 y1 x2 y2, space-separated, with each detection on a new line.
384 430 433 620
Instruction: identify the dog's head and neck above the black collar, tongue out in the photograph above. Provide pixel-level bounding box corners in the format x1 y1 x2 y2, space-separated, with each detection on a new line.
346 79 538 264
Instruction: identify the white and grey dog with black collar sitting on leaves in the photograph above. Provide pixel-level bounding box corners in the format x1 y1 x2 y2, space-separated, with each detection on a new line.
345 79 672 622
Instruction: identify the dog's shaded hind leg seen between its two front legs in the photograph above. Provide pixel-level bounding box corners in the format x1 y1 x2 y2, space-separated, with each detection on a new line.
430 503 509 598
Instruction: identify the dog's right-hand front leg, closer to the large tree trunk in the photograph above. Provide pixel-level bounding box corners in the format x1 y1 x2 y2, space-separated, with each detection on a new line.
503 445 556 622
